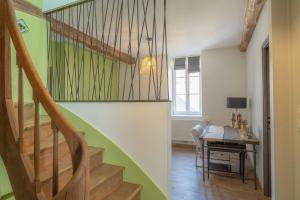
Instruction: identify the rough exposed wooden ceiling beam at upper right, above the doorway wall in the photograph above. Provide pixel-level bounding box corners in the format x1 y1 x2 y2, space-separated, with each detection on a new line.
240 0 266 51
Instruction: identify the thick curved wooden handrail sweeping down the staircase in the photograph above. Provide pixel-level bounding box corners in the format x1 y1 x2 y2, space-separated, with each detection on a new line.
4 0 89 199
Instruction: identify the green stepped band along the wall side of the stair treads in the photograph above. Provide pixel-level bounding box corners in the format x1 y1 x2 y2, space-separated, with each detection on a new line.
60 106 167 200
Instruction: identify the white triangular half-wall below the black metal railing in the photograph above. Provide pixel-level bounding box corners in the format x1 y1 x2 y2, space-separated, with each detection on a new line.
61 103 171 195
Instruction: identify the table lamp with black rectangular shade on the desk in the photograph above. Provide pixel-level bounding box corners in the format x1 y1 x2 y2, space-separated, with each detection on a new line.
227 97 247 129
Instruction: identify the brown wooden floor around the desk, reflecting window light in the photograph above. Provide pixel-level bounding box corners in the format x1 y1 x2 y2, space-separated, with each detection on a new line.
172 147 269 200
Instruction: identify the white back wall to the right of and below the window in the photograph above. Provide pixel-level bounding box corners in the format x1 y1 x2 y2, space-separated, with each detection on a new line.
172 47 246 141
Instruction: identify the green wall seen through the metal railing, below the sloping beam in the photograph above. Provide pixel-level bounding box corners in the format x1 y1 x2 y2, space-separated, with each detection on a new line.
50 39 118 101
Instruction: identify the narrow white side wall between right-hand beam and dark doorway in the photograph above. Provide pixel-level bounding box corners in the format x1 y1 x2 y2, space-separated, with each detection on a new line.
246 0 271 192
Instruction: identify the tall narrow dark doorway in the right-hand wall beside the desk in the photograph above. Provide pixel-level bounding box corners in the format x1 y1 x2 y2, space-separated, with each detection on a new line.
262 38 272 197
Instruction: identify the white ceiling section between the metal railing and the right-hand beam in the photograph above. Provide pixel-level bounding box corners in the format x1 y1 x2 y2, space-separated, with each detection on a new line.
167 0 246 56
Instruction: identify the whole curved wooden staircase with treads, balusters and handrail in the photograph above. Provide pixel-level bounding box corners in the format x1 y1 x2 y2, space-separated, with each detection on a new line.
0 0 141 200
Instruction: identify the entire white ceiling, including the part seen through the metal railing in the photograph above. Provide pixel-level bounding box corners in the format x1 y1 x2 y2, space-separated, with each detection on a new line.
48 0 246 57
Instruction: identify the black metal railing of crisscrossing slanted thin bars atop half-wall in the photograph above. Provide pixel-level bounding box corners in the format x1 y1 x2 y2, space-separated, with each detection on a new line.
46 0 169 102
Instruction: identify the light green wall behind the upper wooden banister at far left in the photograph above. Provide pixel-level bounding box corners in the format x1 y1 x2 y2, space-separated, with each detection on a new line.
0 0 47 199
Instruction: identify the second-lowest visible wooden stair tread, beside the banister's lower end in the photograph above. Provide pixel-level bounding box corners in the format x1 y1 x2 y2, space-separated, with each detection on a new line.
90 164 124 190
